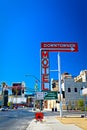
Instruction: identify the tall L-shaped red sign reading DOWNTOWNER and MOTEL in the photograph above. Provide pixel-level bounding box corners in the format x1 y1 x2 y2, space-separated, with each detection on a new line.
41 42 78 91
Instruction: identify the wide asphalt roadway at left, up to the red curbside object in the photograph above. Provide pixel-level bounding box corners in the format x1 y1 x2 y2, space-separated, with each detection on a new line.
0 109 34 130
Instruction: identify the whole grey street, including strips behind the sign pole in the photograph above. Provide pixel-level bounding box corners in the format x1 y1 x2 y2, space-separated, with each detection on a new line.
0 108 84 130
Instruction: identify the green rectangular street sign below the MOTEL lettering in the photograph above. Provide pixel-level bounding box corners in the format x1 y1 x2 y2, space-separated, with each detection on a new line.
44 91 58 100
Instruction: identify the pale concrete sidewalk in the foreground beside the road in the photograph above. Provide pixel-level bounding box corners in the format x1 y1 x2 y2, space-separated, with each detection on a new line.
26 116 82 130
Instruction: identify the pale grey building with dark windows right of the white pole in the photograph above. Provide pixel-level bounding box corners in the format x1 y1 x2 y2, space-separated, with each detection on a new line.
62 78 87 109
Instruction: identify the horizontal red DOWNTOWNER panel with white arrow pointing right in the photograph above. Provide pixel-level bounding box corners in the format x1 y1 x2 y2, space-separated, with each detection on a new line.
41 42 78 52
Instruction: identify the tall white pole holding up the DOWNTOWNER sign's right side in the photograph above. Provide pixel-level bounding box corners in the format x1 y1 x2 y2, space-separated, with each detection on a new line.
58 53 62 117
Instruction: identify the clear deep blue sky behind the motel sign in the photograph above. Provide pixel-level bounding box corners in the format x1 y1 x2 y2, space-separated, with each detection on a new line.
0 0 87 93
